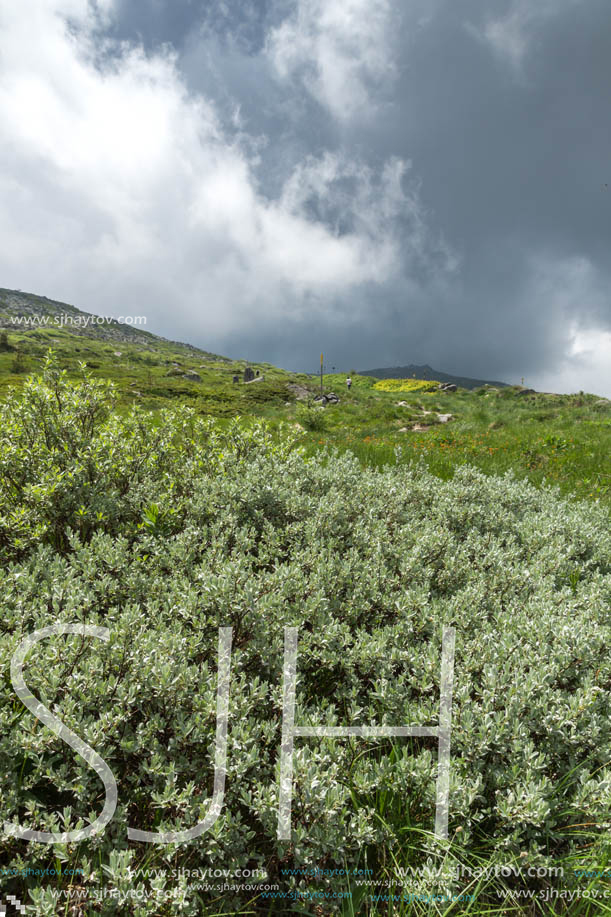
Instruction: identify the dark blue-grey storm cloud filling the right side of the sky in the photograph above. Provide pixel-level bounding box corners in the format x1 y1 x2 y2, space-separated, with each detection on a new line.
137 0 611 379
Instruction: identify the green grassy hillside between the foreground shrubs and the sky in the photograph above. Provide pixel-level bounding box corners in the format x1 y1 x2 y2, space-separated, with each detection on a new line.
0 290 611 503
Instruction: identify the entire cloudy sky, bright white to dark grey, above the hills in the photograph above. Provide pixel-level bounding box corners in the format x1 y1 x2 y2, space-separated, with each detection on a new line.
0 0 611 395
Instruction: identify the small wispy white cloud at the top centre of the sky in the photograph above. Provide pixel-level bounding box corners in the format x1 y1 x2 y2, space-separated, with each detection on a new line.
267 0 398 121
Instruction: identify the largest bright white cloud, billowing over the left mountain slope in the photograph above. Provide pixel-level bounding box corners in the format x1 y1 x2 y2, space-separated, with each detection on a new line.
0 0 450 339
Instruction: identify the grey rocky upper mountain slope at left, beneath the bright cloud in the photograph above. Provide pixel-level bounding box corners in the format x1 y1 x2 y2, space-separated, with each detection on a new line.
0 287 227 360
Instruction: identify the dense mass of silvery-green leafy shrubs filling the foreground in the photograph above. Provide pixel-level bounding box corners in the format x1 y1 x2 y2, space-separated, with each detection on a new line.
0 364 611 915
